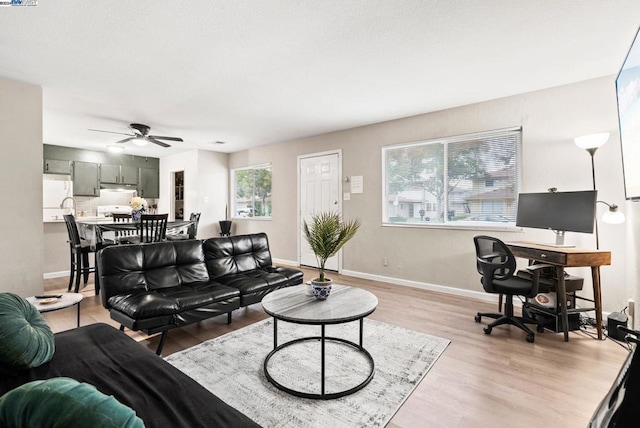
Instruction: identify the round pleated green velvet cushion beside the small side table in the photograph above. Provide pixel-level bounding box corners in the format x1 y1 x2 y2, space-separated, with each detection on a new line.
0 293 55 369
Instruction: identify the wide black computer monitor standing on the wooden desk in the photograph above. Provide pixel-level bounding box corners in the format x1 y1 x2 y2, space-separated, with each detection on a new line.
516 190 598 246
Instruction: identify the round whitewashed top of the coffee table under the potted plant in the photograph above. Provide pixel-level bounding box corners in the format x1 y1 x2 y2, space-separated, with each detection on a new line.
262 284 378 324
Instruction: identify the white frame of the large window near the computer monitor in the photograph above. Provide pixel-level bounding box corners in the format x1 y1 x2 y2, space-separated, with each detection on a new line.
381 126 524 231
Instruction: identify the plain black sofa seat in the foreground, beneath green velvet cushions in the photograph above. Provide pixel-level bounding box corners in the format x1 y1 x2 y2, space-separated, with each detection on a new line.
0 324 259 428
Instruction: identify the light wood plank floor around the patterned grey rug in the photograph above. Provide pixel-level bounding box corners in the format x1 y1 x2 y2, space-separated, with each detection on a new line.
45 270 627 428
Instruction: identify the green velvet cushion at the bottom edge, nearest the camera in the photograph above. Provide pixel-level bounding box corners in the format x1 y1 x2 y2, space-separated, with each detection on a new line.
0 377 144 428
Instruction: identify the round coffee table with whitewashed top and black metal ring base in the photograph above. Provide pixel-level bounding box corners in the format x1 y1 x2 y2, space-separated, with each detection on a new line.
262 284 378 400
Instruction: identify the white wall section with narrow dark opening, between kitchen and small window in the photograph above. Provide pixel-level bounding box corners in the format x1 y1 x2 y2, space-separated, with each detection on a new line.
158 150 229 239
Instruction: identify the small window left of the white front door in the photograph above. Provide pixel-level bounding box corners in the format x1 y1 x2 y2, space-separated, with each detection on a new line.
231 164 271 218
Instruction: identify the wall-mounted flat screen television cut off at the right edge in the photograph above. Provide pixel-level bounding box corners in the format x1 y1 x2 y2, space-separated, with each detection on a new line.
616 25 640 200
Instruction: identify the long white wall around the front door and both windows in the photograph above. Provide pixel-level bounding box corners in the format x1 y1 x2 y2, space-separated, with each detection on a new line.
229 77 640 318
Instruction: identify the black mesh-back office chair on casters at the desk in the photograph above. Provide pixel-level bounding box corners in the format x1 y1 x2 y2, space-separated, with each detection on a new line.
473 235 548 343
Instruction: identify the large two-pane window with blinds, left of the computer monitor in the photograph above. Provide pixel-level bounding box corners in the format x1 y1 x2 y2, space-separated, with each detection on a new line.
382 128 522 226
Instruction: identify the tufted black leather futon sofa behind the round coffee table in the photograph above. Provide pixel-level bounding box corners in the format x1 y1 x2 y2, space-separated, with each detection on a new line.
96 233 303 355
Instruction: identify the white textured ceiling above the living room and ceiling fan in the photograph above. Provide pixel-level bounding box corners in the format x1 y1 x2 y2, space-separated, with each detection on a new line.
0 0 640 156
